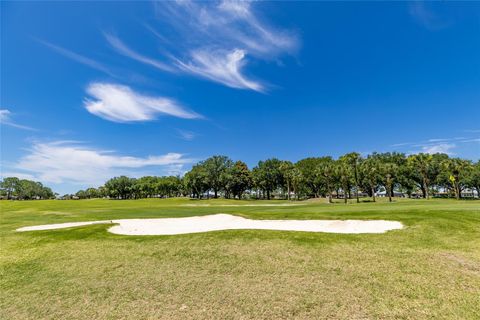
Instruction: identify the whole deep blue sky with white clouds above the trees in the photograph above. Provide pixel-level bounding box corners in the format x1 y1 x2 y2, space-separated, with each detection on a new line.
0 1 480 193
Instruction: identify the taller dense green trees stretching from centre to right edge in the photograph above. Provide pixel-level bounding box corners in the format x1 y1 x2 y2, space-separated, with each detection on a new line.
183 152 480 202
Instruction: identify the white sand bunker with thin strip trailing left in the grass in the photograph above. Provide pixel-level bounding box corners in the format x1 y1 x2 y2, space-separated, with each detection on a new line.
17 214 403 236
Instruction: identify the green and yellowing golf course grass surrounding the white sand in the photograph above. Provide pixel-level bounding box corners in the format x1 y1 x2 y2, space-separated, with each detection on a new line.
0 199 480 319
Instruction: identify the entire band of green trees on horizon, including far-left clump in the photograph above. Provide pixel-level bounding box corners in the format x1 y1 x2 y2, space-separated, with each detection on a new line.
0 152 480 202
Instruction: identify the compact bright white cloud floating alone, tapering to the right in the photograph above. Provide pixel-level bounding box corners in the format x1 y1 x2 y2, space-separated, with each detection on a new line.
84 82 202 122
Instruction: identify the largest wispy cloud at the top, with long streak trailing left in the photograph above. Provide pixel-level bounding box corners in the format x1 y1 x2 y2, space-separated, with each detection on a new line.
105 0 299 92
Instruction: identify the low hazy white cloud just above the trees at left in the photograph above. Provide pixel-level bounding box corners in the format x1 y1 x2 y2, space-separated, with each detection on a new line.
9 141 194 186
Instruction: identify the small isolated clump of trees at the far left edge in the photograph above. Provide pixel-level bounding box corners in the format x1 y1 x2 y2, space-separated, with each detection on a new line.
0 177 55 200
